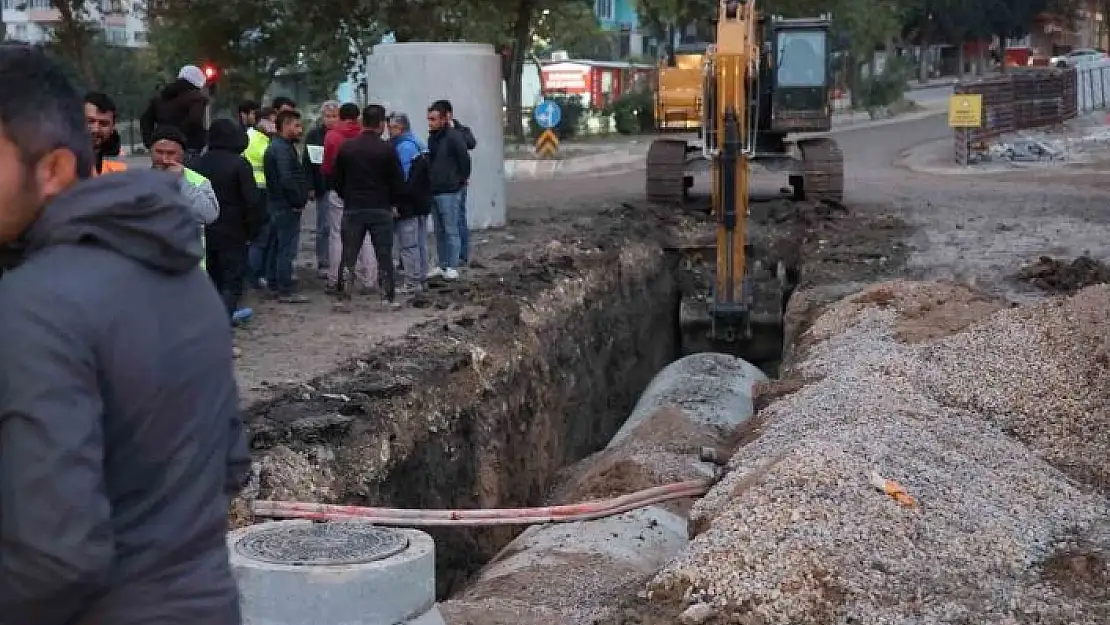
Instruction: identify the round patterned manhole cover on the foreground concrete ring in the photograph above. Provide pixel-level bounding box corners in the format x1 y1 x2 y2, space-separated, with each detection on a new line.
235 523 408 566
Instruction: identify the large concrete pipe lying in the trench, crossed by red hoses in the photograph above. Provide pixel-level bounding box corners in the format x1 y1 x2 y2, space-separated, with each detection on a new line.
440 353 766 625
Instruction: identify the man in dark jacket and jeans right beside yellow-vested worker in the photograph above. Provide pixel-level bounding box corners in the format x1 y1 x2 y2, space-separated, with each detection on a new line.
263 111 309 304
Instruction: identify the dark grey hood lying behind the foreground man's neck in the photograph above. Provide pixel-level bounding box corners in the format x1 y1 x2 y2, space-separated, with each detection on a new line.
27 170 203 274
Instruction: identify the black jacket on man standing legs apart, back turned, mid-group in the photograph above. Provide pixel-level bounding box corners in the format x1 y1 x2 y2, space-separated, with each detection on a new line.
332 132 405 211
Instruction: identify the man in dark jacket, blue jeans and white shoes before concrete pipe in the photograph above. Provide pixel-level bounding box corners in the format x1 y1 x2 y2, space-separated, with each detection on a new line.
427 100 471 280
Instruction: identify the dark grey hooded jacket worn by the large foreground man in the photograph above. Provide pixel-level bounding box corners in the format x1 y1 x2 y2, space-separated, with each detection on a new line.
0 171 250 625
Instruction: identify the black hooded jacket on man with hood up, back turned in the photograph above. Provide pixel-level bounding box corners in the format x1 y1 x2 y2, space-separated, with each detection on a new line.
191 119 266 244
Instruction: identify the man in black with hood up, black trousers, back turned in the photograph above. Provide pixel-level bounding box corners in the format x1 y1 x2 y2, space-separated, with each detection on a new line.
191 119 265 321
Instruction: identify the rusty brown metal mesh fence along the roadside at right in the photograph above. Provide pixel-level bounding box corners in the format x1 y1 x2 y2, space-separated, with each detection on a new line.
953 68 1074 165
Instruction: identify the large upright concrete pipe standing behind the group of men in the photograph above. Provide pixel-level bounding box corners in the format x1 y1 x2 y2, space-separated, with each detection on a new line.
366 43 505 229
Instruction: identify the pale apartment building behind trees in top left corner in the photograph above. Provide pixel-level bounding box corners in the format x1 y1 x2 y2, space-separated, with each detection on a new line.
0 0 147 48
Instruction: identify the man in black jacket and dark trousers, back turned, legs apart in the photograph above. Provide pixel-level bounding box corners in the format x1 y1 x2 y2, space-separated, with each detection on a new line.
332 104 405 303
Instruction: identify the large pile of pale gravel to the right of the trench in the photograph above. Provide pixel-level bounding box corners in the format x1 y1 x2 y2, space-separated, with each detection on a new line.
649 285 1110 625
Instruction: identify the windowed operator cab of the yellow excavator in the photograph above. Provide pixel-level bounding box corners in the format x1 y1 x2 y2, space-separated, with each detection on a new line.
767 18 833 134
